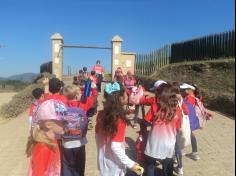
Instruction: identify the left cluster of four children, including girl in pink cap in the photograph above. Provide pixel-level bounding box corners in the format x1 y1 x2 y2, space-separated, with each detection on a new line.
26 78 98 176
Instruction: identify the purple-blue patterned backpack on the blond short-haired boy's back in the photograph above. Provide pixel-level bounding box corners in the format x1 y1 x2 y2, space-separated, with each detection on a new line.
63 108 88 139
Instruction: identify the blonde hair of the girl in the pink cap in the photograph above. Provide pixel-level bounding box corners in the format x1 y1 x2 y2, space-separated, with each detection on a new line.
25 123 56 157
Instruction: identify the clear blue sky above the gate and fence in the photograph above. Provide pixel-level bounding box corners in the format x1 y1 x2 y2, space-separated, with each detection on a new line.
0 0 235 77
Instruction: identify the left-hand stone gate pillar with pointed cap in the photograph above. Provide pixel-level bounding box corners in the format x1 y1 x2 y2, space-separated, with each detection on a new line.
51 33 63 80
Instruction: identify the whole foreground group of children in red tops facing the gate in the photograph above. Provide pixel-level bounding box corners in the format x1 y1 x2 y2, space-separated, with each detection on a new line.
26 66 210 176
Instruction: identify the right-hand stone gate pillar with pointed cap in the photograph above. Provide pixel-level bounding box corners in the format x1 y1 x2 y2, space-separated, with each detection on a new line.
111 35 123 79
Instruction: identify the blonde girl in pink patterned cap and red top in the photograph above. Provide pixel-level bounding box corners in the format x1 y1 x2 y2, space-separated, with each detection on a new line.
26 100 64 176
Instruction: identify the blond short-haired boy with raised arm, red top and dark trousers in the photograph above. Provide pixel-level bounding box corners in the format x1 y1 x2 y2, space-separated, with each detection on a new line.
62 86 96 176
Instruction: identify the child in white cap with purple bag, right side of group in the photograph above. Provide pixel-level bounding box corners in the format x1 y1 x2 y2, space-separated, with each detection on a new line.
180 83 200 161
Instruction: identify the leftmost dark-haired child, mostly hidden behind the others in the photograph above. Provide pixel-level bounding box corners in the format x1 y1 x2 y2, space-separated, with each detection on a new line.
29 88 44 129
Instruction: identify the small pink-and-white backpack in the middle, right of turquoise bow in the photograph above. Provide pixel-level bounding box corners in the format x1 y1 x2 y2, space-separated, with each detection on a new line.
129 86 144 105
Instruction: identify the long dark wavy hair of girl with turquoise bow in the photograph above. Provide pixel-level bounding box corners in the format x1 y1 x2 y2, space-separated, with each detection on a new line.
101 84 128 136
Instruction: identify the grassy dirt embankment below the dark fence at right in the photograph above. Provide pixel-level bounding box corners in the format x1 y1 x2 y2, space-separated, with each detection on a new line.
138 59 235 117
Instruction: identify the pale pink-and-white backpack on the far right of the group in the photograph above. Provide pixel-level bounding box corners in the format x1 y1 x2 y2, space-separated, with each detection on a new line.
195 98 208 128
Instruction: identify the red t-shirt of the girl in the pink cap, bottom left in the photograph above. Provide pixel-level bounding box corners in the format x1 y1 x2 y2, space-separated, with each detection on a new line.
30 141 61 176
